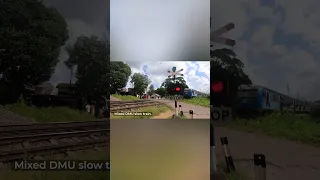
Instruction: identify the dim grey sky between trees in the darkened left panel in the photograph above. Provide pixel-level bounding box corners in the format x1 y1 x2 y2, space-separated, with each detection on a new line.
44 0 110 82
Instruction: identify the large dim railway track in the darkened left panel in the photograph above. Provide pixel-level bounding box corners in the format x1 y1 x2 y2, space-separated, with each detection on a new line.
0 120 110 163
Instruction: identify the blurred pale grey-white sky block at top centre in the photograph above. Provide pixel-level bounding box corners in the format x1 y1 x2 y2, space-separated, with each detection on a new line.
110 0 210 61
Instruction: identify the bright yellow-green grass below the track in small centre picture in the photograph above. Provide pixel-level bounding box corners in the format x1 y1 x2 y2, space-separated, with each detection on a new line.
110 105 172 119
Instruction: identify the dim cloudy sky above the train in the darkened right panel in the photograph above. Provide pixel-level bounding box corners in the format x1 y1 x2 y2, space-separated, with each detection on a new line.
211 0 320 99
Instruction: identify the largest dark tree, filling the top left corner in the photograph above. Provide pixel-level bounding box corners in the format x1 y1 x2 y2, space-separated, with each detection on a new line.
0 0 68 103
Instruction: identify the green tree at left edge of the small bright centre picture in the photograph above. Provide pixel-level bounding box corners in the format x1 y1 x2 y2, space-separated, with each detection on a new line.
110 61 131 94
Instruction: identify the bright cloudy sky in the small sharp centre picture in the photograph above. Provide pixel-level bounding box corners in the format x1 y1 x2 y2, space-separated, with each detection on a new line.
125 61 210 93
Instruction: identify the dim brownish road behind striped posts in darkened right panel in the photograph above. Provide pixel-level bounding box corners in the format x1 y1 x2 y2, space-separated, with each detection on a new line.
215 127 320 180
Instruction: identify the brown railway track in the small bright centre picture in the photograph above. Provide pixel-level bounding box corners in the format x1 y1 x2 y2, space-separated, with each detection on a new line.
110 100 162 113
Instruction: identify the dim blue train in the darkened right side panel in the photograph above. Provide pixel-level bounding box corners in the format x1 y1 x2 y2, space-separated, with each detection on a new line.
236 85 313 112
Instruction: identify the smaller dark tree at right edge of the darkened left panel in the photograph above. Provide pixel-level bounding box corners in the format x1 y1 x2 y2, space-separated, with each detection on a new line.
65 36 110 97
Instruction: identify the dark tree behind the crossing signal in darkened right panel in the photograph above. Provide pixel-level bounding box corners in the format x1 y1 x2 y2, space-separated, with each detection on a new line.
210 49 252 107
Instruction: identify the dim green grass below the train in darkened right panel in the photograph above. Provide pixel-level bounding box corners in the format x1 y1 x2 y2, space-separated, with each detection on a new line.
230 112 320 146
